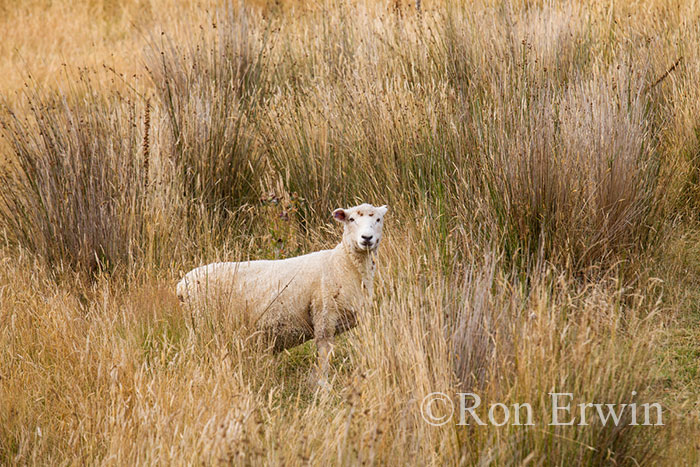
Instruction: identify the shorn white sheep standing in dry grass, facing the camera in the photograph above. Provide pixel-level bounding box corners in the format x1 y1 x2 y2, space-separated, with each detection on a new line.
177 203 388 388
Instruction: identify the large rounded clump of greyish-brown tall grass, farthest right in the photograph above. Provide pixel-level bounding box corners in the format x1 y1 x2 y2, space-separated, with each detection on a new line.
470 65 660 270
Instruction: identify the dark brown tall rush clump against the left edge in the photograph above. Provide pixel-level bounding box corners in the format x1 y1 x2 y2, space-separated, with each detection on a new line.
0 73 148 272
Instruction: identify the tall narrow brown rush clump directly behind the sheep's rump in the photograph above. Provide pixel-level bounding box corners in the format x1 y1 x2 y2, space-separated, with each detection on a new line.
148 7 264 216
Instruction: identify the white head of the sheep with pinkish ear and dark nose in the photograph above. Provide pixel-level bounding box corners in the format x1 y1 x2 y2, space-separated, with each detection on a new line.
333 204 388 252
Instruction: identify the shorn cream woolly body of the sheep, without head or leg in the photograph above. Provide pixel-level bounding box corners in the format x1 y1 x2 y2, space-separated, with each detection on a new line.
177 244 366 351
